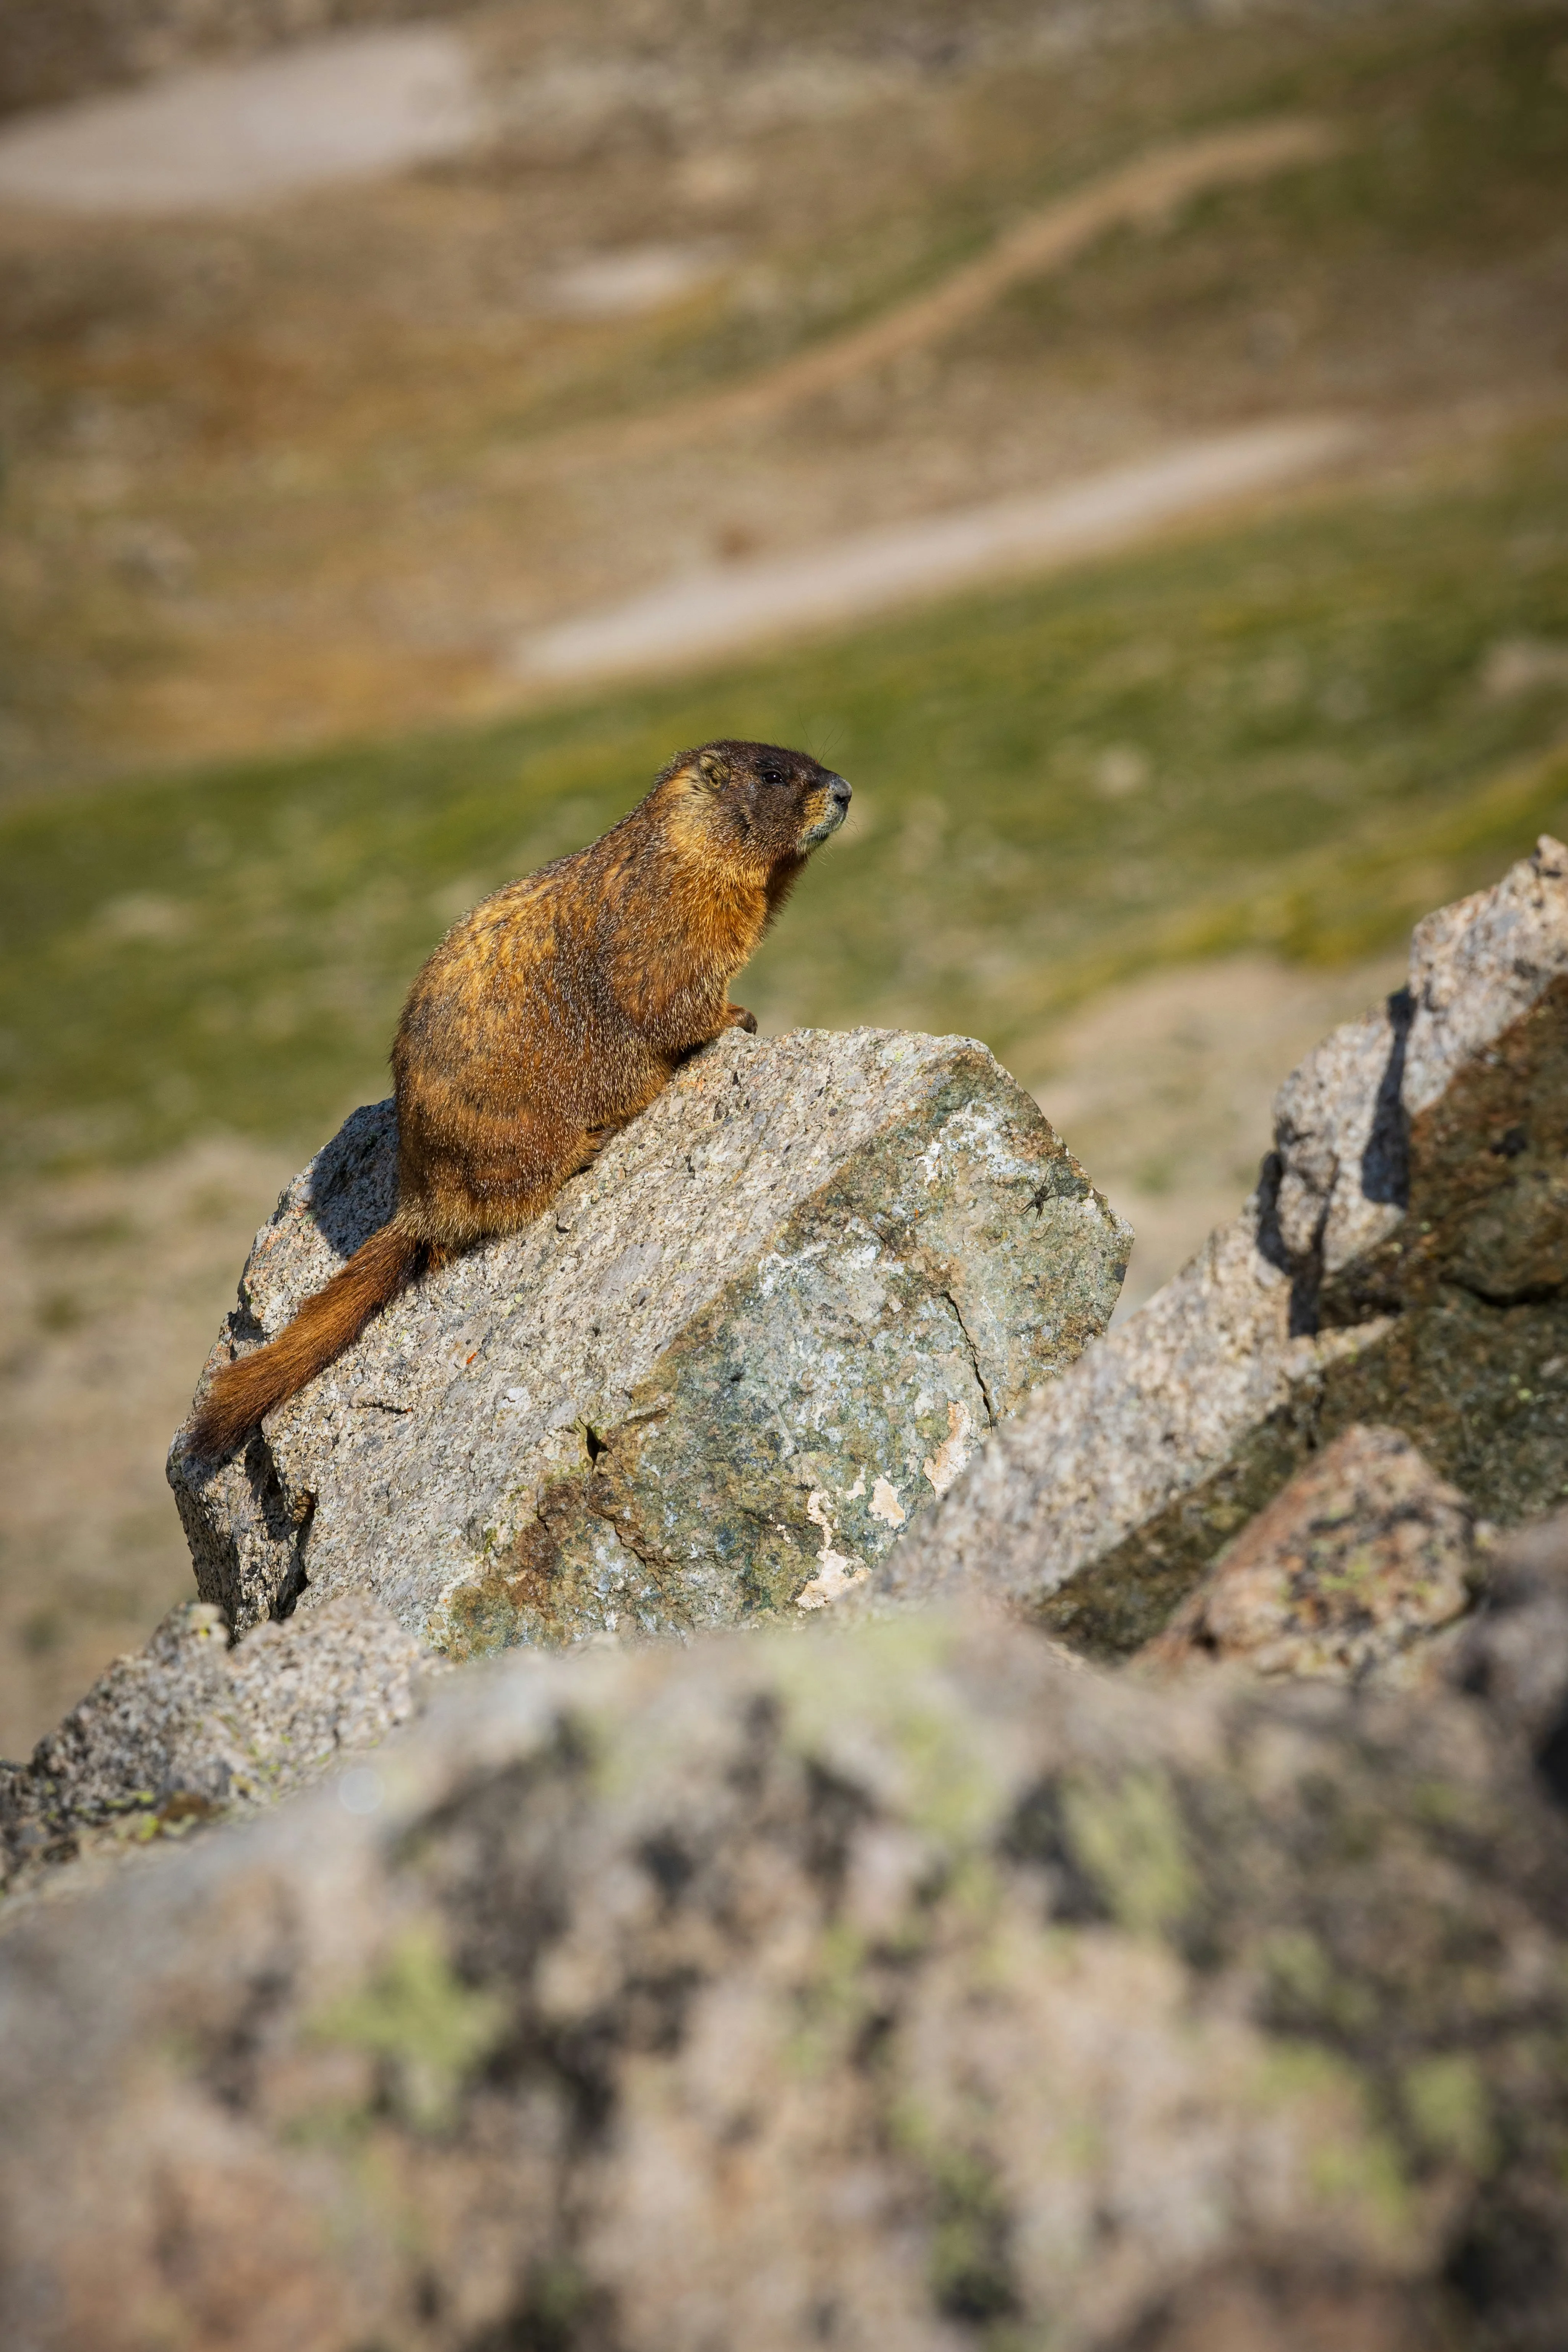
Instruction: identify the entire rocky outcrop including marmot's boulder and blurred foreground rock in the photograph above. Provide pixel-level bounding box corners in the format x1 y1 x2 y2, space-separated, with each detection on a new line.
0 837 1568 2352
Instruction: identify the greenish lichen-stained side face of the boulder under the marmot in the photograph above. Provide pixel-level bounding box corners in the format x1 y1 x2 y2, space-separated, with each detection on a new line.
430 1039 1131 1658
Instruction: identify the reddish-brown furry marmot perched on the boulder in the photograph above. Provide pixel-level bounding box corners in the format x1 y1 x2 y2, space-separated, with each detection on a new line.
190 741 849 1456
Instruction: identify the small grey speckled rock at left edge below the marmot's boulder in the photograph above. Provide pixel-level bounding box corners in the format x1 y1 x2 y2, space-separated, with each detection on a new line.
0 1602 423 1891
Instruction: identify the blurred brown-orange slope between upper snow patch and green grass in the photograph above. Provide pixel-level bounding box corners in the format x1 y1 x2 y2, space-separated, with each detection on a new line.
0 5 1568 797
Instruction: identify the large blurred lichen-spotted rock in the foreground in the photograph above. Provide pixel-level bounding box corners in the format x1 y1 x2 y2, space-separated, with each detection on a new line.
0 1616 1568 2352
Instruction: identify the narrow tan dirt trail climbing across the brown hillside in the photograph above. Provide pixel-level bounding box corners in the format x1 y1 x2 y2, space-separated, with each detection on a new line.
550 115 1342 473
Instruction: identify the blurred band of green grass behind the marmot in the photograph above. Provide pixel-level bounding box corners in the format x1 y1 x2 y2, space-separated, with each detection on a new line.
0 435 1568 1169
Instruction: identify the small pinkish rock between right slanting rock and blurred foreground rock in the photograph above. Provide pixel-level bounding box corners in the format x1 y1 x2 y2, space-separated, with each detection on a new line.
1138 1423 1483 1682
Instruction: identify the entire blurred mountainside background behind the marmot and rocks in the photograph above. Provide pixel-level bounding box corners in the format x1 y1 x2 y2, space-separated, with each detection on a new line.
0 0 1568 1755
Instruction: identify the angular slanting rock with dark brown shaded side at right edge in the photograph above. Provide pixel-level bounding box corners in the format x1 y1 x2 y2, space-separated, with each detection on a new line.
879 840 1568 1656
